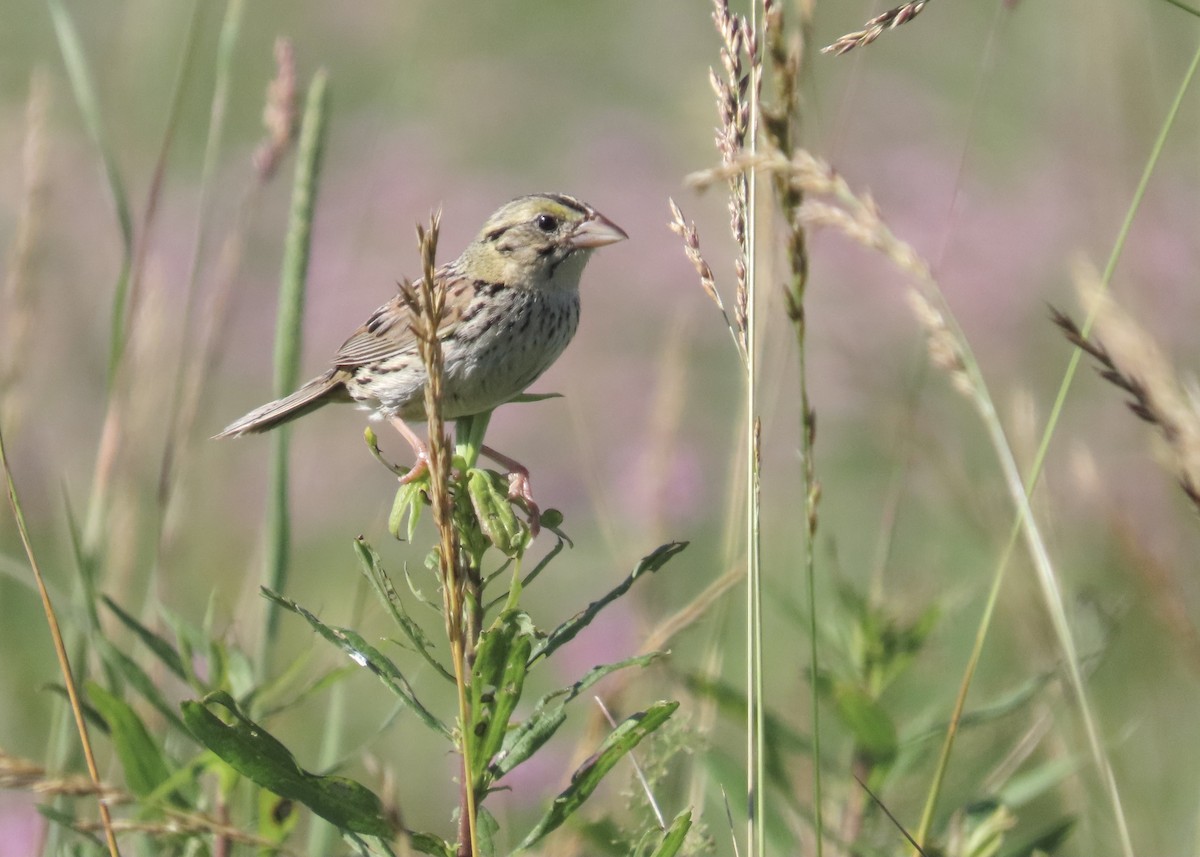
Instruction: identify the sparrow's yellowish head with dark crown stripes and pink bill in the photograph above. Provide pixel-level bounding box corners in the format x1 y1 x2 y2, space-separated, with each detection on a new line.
460 193 629 289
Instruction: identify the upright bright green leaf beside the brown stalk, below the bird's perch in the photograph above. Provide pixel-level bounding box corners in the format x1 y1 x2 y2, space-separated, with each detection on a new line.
467 610 533 798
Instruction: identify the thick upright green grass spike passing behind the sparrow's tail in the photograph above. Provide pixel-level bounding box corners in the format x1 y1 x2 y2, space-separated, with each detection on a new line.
258 70 329 675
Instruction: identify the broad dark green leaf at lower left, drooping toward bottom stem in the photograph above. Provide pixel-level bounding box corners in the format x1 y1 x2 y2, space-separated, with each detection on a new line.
181 691 394 838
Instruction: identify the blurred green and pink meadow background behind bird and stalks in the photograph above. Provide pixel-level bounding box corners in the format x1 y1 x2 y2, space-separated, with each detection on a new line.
0 0 1200 855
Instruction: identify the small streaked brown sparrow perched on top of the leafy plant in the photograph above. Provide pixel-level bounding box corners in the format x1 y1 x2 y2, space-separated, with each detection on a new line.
216 193 628 526
